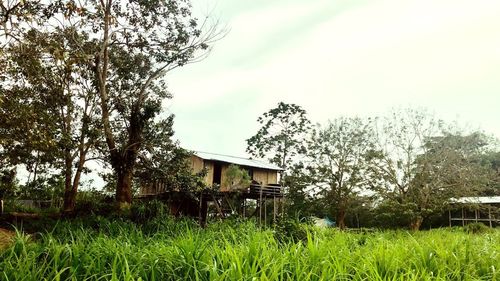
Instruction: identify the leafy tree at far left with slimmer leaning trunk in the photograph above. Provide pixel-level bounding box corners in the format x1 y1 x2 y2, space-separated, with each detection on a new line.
0 24 99 212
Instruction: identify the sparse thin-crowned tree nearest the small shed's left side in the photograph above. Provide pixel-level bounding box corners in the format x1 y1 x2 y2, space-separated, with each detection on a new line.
372 108 441 229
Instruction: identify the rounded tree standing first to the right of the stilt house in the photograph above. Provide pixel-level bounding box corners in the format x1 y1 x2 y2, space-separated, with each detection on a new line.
308 118 379 229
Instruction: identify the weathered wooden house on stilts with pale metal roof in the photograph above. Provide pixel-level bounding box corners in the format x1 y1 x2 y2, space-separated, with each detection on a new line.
139 152 283 225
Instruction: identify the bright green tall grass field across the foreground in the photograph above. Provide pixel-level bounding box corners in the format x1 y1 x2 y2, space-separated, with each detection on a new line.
0 217 500 280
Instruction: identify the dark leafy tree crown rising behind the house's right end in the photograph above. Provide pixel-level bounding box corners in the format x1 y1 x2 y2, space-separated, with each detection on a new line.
247 102 311 175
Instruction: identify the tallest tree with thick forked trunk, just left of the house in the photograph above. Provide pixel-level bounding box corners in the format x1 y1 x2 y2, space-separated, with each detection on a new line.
85 0 220 208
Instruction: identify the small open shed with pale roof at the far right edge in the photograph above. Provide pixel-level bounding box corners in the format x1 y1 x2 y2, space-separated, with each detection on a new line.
448 196 500 227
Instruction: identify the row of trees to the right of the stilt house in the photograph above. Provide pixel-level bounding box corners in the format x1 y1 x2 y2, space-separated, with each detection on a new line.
247 102 500 229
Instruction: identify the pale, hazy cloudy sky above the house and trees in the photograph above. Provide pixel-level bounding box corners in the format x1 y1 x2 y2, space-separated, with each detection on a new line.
165 0 500 156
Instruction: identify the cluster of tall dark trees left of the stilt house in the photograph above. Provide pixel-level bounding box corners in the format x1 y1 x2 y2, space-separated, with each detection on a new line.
0 0 223 212
